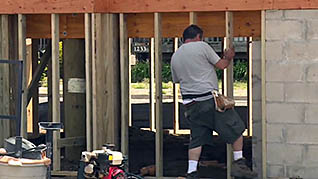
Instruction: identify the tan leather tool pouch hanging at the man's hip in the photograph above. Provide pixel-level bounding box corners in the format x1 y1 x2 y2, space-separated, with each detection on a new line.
212 90 235 112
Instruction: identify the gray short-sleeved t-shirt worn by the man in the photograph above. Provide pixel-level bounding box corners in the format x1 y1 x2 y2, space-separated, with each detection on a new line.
171 41 220 95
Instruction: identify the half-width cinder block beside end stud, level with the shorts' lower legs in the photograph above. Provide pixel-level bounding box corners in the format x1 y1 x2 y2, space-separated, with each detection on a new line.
267 124 285 142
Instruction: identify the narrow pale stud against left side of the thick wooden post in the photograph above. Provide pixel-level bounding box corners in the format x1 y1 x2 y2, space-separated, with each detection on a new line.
85 13 93 151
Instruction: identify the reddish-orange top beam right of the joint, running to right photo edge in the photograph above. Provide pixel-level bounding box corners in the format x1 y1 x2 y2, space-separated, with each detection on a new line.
106 0 318 13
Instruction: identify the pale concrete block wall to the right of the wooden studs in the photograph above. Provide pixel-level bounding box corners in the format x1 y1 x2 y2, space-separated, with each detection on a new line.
266 10 318 179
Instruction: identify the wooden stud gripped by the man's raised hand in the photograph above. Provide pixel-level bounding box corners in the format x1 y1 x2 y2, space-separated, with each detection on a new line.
224 11 233 179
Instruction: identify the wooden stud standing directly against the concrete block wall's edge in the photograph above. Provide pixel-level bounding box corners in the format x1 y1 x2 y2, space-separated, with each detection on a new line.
261 11 267 179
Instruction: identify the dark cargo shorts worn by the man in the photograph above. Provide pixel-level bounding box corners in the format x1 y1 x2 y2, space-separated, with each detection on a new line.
185 98 245 149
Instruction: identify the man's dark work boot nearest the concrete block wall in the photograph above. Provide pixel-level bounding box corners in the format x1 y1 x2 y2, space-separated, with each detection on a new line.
231 158 257 178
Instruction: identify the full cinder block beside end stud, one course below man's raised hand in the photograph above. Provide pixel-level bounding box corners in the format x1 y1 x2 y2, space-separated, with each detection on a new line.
266 63 305 82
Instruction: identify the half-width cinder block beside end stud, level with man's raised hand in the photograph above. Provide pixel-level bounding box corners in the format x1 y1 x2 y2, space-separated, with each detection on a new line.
266 41 284 61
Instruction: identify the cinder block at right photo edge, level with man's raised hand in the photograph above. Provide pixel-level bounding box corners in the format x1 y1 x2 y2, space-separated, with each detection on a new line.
285 40 318 61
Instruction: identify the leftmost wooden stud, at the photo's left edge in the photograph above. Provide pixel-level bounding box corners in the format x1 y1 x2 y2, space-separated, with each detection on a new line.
0 15 10 146
